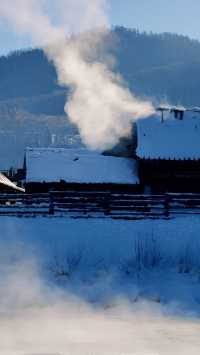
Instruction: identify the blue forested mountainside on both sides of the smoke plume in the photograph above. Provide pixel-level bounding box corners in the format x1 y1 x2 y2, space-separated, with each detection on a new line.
0 27 200 168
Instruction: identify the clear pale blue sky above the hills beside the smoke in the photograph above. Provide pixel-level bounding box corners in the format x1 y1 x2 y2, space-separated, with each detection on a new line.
0 0 200 54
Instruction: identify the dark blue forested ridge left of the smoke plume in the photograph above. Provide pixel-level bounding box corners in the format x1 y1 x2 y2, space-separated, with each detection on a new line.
0 49 58 100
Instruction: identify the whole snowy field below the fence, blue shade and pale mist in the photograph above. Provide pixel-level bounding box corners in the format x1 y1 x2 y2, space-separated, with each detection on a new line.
0 216 200 355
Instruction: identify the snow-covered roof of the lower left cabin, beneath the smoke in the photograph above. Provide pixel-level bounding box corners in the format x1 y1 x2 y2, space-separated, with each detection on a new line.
26 148 139 184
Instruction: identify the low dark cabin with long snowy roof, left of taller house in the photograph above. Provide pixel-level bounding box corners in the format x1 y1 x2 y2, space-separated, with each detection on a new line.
25 148 139 192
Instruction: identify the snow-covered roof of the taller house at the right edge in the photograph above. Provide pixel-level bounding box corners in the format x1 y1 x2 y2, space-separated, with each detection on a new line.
136 110 200 160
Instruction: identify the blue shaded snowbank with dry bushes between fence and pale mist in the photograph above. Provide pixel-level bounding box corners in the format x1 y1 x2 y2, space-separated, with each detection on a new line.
0 216 200 311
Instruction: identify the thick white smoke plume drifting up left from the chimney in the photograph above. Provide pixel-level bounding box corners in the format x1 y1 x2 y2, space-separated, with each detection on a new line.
0 0 154 150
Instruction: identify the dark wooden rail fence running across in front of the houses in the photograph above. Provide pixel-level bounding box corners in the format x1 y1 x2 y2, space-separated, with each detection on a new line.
0 191 200 220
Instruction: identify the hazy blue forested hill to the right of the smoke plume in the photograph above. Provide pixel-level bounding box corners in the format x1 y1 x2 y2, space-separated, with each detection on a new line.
111 27 200 105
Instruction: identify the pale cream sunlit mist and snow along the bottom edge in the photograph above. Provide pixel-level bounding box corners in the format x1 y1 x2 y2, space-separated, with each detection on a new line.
0 300 200 355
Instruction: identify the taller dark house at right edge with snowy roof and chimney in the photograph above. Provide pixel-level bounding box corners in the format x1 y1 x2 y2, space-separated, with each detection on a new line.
136 107 200 192
